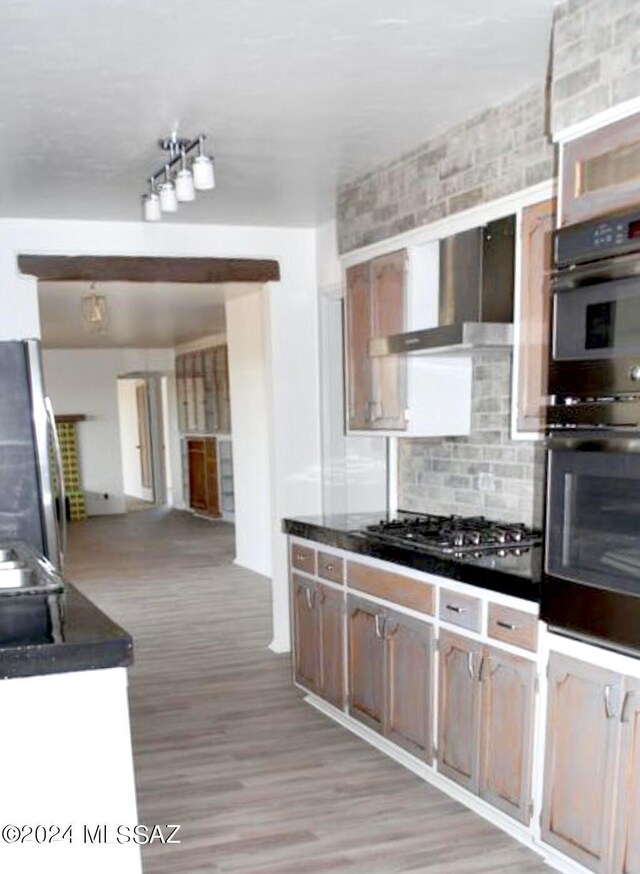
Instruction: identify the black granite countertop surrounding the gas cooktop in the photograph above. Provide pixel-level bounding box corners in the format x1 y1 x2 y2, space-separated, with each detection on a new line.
282 512 542 602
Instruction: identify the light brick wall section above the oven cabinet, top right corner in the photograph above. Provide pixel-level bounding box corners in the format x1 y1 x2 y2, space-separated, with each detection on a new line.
551 0 640 131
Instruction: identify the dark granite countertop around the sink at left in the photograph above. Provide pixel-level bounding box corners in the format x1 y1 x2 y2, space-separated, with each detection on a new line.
0 583 133 679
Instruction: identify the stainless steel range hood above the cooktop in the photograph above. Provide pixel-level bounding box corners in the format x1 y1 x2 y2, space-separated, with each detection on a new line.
369 216 515 357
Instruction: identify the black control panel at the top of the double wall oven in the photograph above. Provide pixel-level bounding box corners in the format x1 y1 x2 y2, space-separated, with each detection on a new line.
555 209 640 269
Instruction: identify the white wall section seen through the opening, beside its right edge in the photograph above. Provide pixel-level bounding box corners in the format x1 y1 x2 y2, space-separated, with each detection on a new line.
225 288 272 575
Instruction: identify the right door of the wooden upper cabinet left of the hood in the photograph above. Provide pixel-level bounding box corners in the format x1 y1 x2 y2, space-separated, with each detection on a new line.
371 249 407 431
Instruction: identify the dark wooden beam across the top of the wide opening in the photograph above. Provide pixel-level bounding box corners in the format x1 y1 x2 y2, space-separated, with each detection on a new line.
18 255 280 283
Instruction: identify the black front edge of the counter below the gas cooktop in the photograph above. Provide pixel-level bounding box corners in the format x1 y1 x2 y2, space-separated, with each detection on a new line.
282 519 540 603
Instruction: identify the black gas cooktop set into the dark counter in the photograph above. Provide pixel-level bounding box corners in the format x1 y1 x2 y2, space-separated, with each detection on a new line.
366 514 542 558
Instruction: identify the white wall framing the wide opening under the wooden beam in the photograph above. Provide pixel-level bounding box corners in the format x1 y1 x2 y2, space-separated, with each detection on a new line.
0 219 321 651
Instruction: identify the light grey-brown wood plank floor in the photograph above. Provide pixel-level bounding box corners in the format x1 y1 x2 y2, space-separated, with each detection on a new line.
68 510 550 874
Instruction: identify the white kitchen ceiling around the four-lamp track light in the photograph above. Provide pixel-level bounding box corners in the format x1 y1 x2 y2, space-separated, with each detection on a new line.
0 0 555 226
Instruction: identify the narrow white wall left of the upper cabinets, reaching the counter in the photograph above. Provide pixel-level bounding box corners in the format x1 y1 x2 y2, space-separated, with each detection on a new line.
316 221 387 514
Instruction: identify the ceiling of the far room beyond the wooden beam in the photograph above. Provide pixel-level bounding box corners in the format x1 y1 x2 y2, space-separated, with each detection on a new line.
38 282 245 349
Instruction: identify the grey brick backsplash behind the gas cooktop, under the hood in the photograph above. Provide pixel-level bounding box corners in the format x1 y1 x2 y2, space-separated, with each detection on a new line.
398 349 544 526
